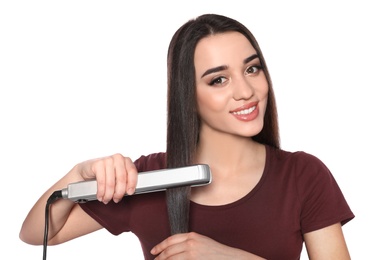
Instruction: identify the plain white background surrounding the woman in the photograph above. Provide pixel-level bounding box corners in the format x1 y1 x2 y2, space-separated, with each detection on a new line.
0 0 372 260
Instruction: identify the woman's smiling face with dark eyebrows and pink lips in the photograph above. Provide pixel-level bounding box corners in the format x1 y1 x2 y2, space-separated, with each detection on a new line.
194 32 268 137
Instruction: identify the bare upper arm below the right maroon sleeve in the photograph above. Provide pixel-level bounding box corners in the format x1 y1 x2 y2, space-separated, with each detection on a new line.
304 223 351 260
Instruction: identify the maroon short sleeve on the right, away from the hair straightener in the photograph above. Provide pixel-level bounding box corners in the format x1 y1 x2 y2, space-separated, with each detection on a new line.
296 152 354 233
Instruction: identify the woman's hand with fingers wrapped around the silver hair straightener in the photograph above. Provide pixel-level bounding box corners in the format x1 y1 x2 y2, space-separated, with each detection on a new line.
76 154 138 204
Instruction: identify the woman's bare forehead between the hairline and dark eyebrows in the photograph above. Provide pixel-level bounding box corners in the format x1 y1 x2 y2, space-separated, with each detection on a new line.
194 32 256 67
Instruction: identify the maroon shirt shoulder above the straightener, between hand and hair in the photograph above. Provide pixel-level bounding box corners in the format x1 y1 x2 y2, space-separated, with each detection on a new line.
134 152 167 172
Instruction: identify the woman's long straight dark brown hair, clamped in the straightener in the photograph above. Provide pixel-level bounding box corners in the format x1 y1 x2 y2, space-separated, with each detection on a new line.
167 14 280 234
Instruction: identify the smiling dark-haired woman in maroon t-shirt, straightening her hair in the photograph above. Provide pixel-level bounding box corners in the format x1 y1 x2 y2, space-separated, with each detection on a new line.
20 14 354 259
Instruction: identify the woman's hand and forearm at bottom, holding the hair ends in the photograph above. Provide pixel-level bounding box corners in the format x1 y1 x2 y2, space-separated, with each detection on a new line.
151 232 262 260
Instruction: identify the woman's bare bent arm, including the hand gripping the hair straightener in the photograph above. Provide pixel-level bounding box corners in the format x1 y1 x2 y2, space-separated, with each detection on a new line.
19 154 137 245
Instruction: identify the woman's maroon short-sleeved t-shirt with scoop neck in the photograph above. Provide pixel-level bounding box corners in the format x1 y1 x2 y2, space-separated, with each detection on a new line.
80 146 354 260
